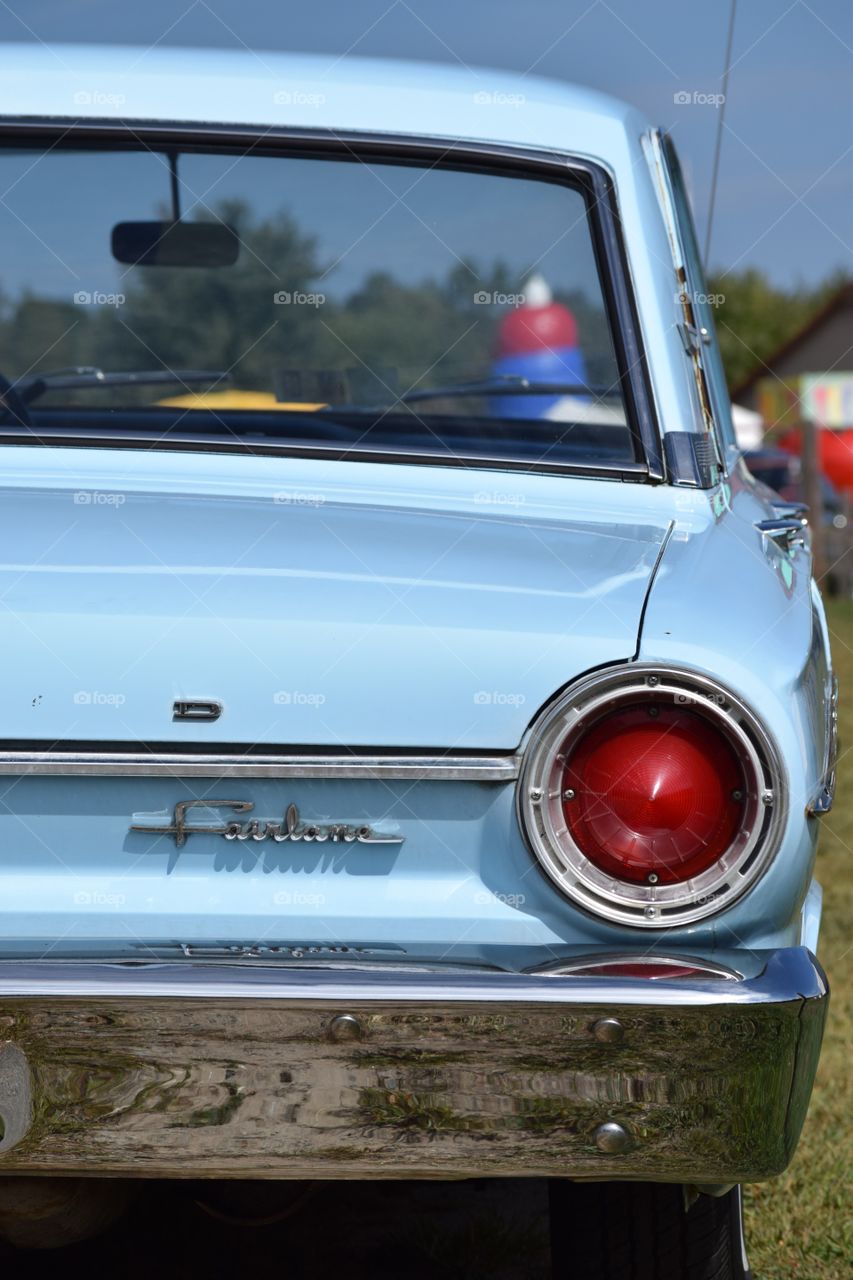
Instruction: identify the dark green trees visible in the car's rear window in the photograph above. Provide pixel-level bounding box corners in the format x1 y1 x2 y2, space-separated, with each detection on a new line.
0 201 615 406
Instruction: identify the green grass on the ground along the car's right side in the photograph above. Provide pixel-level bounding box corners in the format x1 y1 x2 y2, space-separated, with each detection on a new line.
747 600 853 1280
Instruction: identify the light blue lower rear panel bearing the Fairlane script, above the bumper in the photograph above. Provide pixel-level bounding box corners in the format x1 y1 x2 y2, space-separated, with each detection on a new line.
0 762 813 972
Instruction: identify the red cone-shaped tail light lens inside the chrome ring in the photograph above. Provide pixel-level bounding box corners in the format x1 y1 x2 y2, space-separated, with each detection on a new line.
562 704 745 884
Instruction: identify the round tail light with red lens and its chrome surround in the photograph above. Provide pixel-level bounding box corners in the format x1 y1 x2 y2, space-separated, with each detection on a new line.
520 668 781 928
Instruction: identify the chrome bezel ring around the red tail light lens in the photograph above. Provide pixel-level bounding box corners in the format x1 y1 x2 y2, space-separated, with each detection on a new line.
516 663 788 929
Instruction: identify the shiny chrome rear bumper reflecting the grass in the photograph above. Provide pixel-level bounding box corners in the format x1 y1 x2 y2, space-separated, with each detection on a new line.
0 947 827 1183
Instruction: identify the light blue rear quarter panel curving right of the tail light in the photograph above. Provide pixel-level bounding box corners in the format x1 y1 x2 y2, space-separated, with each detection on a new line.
639 474 831 947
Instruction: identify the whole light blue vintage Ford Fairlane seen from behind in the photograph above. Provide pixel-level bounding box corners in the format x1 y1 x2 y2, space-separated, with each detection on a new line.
0 46 835 1280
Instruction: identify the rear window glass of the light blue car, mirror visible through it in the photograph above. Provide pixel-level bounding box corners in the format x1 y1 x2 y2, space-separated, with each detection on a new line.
0 146 638 465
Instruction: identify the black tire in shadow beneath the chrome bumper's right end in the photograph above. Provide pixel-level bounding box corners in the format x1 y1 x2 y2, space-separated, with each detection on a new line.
549 1179 751 1280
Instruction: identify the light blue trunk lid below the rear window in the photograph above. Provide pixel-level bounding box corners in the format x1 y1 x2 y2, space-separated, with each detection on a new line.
0 449 670 750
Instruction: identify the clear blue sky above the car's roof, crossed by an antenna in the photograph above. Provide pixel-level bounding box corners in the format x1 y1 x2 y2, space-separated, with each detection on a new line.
0 0 853 285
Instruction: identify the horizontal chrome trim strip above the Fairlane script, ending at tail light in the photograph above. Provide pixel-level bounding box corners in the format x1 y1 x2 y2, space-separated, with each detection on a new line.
0 751 520 782
